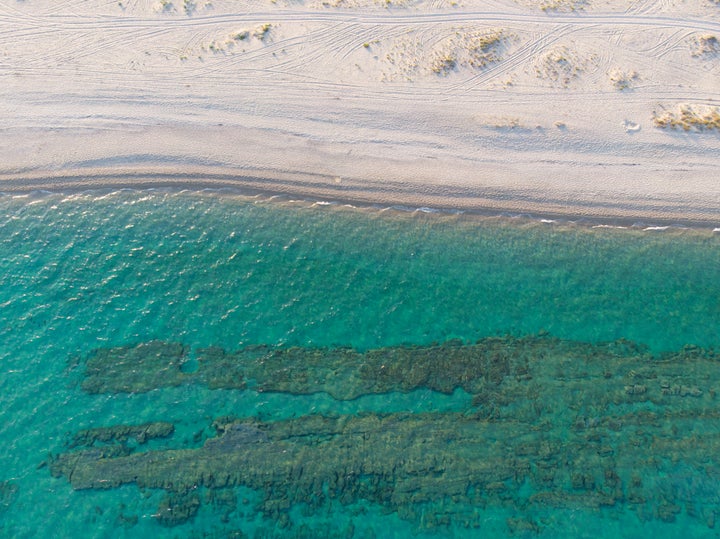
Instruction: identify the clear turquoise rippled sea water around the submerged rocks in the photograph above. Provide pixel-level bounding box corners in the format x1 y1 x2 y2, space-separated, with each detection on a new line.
0 191 720 537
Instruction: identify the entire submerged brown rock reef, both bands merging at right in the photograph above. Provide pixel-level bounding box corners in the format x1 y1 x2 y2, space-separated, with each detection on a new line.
48 334 720 537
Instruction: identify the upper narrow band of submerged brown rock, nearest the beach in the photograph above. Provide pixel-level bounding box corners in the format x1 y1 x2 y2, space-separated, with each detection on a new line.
82 336 715 400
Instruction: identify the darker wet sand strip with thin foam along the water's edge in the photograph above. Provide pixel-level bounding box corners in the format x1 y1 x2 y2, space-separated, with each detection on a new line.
0 170 720 232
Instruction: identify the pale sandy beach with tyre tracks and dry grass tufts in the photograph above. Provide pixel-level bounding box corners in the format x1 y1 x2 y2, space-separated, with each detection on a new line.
0 0 720 225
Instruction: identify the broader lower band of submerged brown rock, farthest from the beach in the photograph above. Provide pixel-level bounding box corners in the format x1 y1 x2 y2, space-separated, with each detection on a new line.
51 413 720 527
